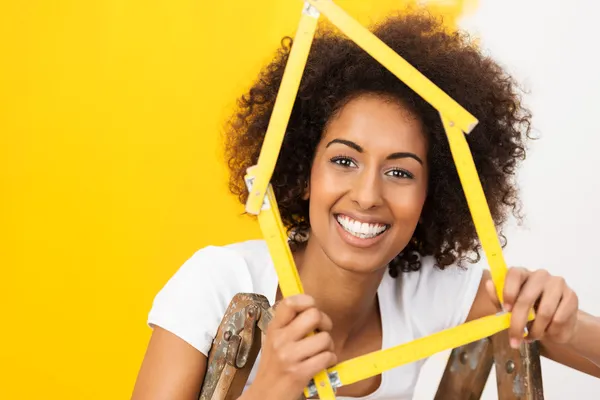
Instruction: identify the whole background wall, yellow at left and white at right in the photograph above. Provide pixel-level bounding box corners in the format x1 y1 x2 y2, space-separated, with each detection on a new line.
0 0 600 399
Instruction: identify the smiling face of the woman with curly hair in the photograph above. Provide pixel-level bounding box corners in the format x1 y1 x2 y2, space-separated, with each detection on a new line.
309 95 427 272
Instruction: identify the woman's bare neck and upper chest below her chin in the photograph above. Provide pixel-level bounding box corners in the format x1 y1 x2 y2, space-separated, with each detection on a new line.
295 239 386 349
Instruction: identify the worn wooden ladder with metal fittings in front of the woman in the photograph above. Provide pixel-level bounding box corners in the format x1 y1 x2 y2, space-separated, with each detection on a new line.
199 293 544 400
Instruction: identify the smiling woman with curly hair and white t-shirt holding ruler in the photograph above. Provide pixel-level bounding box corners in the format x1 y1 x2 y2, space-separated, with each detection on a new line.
133 12 600 400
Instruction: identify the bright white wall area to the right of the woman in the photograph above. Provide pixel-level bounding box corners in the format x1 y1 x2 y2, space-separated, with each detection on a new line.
415 0 600 400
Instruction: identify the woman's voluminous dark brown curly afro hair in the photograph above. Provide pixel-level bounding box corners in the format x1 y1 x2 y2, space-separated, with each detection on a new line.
225 11 531 277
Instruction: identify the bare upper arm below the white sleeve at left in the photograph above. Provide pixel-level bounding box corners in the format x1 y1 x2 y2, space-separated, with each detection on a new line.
131 326 206 400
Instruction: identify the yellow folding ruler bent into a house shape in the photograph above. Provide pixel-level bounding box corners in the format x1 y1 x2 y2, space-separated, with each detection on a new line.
246 0 534 400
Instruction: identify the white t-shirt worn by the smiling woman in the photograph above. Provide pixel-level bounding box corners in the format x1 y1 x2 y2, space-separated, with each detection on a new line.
148 240 483 400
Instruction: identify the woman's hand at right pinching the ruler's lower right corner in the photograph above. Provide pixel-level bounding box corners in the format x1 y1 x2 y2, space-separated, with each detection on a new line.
486 268 579 348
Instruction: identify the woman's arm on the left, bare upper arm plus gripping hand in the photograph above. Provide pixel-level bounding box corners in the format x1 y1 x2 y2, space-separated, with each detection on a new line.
132 294 337 400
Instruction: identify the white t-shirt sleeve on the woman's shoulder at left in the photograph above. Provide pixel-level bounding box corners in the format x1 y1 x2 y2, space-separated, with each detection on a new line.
148 246 252 355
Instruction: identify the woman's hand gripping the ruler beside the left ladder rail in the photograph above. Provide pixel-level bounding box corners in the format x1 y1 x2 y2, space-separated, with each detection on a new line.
242 294 337 400
